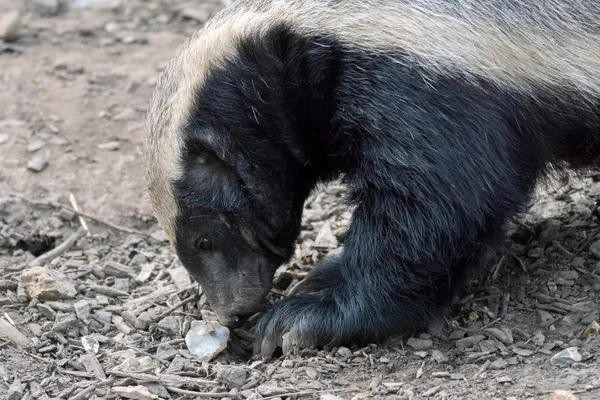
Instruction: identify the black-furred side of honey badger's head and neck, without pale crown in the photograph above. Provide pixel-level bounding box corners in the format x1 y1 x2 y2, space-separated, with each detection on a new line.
162 23 335 326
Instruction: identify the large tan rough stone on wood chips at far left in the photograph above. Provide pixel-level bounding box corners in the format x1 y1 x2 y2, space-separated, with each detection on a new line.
21 267 77 301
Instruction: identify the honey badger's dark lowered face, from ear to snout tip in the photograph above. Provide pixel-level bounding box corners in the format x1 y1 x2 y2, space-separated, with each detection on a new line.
175 139 299 327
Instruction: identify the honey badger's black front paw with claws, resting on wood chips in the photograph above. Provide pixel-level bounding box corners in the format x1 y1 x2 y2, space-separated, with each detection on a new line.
254 293 343 358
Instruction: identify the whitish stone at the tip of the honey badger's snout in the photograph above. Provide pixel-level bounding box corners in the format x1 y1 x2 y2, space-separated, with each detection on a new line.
185 321 229 361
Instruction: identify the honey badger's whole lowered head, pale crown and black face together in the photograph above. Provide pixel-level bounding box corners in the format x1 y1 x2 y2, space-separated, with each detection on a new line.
144 2 338 327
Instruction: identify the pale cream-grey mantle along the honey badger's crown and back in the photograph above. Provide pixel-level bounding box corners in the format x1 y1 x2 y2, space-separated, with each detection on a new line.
144 0 600 243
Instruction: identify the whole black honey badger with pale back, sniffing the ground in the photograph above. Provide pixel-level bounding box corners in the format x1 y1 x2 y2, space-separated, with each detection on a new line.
144 0 600 356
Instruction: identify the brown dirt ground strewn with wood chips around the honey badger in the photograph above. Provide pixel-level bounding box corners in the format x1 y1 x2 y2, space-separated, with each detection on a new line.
0 0 600 400
